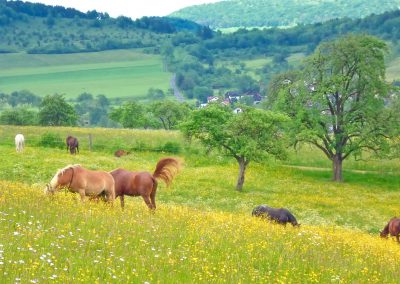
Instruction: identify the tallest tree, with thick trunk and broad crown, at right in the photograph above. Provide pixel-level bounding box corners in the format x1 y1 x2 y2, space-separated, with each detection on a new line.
269 35 399 181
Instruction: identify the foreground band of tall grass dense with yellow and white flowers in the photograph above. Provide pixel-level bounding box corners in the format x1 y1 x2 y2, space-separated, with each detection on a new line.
0 182 400 283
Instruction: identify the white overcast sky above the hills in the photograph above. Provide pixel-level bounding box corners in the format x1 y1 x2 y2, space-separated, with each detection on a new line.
29 0 220 19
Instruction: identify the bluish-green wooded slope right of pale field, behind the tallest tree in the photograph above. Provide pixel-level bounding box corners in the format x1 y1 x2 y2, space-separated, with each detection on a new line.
160 7 400 102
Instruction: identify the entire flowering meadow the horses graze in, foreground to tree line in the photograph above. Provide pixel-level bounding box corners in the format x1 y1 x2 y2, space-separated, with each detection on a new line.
0 127 400 283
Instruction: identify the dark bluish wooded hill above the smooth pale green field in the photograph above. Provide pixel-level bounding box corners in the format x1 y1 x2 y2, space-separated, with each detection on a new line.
0 0 210 53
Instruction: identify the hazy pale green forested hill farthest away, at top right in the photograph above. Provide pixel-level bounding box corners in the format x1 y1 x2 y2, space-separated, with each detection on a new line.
170 0 400 28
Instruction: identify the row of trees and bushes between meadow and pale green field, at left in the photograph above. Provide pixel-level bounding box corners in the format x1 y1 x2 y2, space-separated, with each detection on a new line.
0 89 192 130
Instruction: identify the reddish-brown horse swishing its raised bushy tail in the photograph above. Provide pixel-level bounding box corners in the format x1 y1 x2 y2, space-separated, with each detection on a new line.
110 158 180 209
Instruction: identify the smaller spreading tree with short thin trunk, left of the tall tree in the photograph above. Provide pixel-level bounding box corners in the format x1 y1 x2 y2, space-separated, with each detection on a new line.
181 104 287 191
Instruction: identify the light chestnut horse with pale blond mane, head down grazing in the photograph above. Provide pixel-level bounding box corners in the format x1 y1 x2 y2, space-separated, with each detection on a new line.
45 165 115 202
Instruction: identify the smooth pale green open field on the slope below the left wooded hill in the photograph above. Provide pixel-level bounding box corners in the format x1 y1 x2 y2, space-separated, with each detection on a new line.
0 50 171 98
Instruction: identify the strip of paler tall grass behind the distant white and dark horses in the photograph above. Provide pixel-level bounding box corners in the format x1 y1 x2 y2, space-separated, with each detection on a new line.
0 125 194 153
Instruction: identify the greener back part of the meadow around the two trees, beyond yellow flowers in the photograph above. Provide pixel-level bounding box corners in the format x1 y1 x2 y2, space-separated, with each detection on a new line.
0 126 400 233
